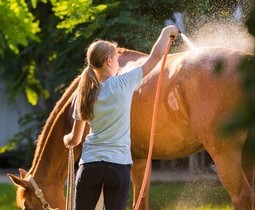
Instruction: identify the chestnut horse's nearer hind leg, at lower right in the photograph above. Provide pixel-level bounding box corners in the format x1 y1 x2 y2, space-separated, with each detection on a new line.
204 135 253 210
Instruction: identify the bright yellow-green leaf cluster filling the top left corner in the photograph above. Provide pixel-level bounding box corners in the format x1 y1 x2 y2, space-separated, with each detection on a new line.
0 0 40 56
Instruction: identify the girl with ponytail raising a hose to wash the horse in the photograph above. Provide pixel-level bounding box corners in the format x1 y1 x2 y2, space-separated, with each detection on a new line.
64 25 178 210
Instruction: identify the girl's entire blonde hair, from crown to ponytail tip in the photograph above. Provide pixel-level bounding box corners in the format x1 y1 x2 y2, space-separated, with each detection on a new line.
77 40 117 121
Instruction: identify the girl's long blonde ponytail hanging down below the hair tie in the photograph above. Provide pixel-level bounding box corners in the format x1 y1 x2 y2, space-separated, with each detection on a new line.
77 65 100 121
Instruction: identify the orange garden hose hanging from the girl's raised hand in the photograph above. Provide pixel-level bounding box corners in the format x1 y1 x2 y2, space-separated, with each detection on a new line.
134 37 172 210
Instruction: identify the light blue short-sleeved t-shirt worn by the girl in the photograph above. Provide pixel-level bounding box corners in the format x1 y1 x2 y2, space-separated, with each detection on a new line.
74 66 143 164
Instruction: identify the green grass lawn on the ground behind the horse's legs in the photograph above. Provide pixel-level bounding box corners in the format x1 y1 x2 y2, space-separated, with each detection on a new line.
0 182 233 210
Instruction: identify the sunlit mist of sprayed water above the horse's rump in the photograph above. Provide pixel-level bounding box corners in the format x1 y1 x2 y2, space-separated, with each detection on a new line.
174 0 255 53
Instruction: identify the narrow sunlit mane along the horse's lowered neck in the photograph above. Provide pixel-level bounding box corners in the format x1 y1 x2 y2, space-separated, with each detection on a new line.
30 75 80 171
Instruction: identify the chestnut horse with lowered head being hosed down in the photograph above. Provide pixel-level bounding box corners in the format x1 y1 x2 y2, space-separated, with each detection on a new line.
9 47 254 210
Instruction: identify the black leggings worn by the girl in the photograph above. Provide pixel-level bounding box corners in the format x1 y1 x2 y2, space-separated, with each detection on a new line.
75 162 131 210
